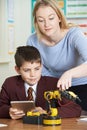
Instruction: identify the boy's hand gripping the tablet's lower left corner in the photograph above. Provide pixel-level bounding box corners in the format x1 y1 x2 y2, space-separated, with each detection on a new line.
9 107 25 120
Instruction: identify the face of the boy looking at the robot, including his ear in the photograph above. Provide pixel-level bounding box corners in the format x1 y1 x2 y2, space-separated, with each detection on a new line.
15 62 42 85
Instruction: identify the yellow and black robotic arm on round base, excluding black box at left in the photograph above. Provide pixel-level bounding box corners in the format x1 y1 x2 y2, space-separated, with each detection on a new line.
43 90 80 125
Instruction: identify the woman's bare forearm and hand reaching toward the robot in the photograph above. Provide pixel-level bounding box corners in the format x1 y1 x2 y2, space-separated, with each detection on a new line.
57 62 87 90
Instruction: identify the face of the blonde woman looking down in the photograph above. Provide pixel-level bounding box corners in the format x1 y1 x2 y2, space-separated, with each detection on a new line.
36 6 60 37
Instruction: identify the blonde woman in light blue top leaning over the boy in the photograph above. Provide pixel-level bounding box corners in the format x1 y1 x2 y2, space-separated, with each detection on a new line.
27 0 87 110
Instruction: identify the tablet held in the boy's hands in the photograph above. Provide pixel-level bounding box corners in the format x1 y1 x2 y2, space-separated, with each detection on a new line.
11 101 35 113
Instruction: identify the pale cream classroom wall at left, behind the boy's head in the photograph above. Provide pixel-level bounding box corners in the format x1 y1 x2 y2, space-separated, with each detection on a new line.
0 0 31 88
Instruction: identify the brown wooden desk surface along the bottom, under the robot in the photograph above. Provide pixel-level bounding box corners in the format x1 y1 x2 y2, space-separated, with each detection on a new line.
0 118 87 130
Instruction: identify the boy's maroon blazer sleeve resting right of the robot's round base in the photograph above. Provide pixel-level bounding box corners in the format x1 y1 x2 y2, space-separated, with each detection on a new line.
58 98 82 118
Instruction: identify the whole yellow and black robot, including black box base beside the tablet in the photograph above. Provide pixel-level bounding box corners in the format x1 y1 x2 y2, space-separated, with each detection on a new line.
23 90 80 126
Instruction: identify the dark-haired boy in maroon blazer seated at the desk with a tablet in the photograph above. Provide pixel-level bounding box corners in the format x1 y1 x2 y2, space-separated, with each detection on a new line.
0 46 81 119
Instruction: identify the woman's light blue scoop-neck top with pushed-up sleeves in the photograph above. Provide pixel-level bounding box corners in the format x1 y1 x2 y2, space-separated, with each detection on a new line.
27 27 87 86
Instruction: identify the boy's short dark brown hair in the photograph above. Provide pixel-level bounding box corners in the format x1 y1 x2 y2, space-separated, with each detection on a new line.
14 46 41 68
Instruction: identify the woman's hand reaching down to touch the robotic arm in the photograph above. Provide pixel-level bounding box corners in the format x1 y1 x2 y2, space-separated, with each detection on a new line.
57 71 72 90
